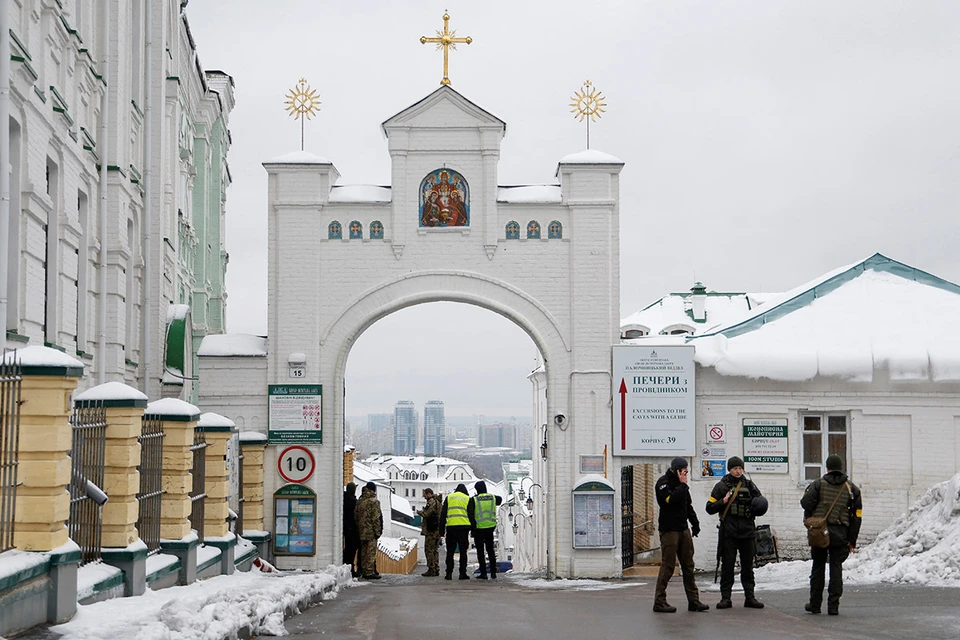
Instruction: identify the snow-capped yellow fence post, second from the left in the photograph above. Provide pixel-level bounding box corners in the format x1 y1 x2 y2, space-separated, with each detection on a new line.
76 382 147 596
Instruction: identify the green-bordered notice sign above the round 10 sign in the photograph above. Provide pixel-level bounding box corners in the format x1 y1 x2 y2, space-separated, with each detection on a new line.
267 384 323 444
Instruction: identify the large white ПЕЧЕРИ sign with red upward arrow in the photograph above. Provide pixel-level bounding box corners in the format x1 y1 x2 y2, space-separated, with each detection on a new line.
613 345 696 457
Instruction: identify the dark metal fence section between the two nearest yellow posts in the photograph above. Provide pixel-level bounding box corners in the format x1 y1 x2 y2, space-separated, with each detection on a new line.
67 403 107 565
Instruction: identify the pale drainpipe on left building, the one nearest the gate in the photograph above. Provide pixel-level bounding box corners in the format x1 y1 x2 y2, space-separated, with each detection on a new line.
140 2 153 396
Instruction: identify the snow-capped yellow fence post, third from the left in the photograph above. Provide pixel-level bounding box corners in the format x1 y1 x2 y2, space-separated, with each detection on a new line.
144 398 200 584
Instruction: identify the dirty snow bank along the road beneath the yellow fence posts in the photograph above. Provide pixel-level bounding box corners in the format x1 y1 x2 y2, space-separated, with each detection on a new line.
53 565 351 640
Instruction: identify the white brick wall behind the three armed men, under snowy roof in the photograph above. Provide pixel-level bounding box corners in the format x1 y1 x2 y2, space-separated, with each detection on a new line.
691 367 960 569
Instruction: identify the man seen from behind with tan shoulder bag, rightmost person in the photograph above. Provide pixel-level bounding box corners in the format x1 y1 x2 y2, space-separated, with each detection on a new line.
800 454 863 616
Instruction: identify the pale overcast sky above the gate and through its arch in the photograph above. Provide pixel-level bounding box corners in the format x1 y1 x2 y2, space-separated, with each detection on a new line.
186 0 960 416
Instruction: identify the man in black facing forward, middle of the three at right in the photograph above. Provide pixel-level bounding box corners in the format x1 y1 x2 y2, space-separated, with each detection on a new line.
707 456 763 609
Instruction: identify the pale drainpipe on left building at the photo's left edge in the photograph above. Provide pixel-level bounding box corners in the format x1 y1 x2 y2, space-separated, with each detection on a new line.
0 10 10 354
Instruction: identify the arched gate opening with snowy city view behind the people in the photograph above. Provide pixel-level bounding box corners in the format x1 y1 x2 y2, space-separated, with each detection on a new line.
342 302 547 573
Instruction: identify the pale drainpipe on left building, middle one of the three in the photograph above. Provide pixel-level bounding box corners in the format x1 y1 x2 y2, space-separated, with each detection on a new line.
97 0 110 384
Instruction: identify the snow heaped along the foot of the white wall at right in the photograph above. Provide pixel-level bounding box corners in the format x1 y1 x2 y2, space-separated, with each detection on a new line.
706 474 960 591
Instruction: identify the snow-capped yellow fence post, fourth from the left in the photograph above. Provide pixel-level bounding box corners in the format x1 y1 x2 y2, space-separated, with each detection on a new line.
197 413 237 575
